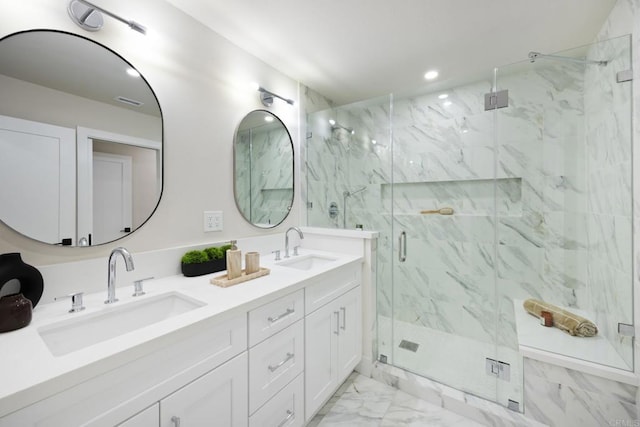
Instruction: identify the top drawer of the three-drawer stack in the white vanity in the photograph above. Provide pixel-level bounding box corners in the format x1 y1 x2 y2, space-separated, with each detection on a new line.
249 289 304 347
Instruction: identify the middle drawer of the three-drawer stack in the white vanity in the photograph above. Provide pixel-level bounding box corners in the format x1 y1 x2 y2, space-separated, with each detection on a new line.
249 320 304 414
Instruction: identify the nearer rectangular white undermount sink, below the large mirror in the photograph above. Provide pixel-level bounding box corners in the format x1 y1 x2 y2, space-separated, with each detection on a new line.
38 292 206 356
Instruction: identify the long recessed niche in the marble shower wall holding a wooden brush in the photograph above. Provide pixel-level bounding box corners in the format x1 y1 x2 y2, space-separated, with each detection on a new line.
381 177 522 217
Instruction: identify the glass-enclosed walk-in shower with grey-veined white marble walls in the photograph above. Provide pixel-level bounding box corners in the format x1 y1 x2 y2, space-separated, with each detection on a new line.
305 37 633 410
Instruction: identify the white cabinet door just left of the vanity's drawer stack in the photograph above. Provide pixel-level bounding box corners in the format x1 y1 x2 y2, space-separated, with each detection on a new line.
160 352 248 427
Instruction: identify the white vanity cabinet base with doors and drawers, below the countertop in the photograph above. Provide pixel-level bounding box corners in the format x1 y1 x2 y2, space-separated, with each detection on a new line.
0 254 362 427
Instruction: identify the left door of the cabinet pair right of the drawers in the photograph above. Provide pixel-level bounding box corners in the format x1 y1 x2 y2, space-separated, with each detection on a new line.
305 304 340 419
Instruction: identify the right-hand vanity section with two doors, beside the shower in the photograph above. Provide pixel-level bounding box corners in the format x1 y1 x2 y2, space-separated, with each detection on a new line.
305 266 362 420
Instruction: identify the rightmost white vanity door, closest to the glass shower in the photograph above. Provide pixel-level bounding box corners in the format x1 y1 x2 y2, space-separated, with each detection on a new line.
336 286 362 383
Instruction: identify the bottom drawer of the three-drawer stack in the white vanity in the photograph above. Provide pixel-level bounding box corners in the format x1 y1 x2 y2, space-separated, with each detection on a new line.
249 374 304 427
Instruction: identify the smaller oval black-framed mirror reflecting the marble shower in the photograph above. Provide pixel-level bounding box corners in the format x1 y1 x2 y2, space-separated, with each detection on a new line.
233 110 293 228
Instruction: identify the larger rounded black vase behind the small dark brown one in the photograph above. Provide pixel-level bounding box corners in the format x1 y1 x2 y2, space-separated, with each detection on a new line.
0 252 44 307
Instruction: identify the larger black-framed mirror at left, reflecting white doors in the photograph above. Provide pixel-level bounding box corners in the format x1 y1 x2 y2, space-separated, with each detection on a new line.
0 30 163 246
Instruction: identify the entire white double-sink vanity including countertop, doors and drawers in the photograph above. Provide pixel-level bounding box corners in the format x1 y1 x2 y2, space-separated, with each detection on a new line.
0 249 363 427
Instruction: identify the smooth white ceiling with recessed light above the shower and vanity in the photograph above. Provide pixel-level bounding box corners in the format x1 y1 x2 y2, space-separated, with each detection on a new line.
167 0 616 104
